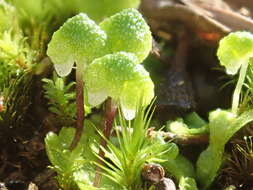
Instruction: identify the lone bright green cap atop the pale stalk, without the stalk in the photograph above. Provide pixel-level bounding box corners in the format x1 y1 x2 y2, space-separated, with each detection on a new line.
217 32 253 75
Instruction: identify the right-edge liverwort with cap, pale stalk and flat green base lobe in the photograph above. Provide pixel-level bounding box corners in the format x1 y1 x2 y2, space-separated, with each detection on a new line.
197 32 253 189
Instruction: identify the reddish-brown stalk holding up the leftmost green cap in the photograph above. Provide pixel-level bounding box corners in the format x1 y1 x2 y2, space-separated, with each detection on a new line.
70 63 84 150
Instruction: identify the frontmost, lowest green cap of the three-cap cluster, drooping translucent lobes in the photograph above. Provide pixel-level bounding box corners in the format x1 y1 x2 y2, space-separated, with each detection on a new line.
85 52 154 120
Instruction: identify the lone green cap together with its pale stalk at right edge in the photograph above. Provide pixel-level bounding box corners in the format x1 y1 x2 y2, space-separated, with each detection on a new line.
217 32 253 113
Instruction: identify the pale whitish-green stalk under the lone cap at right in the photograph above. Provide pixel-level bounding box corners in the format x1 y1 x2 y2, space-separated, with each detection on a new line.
232 63 248 114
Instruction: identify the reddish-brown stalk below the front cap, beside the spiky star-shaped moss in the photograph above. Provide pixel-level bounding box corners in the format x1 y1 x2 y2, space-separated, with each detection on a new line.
93 98 117 187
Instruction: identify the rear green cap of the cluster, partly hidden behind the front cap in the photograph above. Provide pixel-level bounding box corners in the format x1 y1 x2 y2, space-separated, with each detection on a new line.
100 9 152 63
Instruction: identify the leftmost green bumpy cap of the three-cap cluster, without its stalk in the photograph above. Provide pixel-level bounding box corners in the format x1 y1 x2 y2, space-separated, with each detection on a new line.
47 13 106 76
